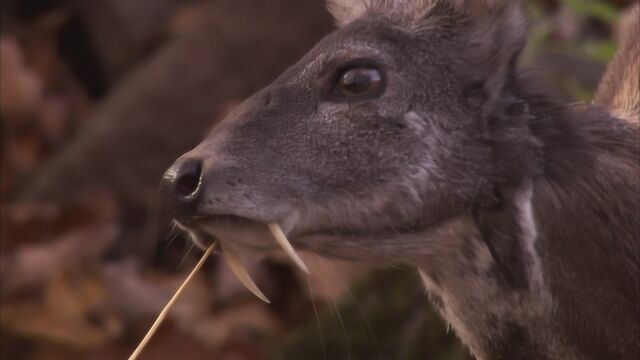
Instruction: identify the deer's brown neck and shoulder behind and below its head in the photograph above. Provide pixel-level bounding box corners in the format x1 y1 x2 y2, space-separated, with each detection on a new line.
417 102 640 359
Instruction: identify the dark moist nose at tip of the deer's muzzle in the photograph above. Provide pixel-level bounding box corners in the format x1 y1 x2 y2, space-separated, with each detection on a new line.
160 158 202 220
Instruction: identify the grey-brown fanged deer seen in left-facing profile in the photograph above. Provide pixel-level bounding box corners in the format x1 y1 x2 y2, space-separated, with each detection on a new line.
161 0 640 359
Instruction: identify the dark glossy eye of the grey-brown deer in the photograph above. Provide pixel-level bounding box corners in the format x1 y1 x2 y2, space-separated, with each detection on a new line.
334 67 382 98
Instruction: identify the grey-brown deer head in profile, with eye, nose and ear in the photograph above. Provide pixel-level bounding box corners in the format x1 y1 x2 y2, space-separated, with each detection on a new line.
163 0 527 261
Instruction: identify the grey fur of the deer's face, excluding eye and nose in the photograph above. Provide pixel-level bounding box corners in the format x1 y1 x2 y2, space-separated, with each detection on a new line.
182 2 517 245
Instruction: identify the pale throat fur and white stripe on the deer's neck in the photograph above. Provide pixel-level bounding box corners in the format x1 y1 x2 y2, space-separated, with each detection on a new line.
417 185 556 358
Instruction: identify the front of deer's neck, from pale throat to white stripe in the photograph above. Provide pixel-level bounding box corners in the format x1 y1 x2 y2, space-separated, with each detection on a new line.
418 184 573 359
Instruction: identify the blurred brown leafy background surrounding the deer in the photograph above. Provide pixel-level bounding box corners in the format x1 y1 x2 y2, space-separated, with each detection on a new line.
0 0 631 360
